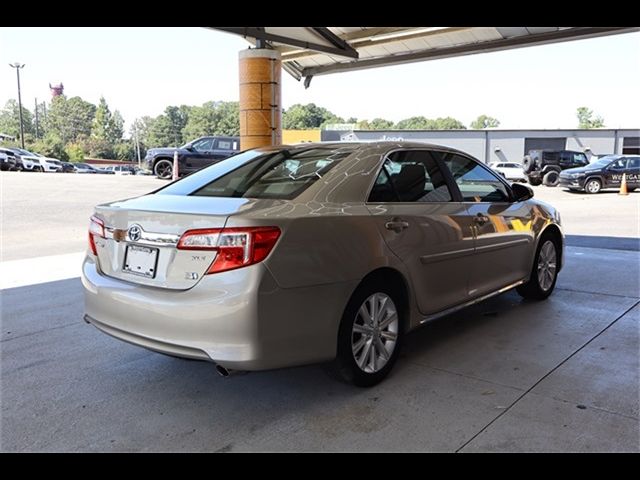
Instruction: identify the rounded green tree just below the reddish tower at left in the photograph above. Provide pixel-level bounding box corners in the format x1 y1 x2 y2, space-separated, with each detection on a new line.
47 95 96 144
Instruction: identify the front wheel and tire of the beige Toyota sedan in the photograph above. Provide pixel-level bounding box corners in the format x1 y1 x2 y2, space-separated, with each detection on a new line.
516 235 560 300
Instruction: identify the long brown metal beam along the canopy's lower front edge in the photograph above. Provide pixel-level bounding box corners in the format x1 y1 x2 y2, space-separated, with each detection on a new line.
302 27 640 77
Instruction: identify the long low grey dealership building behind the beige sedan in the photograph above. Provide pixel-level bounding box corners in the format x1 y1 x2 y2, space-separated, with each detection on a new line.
338 128 640 163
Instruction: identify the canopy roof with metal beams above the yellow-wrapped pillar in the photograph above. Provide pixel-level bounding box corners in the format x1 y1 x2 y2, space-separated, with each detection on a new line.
207 27 640 86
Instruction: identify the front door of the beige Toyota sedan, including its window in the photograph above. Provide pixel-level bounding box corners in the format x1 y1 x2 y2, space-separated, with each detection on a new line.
444 154 543 298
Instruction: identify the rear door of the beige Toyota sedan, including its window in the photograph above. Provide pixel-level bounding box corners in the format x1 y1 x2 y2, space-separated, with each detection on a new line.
367 150 474 314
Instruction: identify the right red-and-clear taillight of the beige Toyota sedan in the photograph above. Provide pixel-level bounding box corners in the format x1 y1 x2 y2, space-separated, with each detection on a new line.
177 227 280 273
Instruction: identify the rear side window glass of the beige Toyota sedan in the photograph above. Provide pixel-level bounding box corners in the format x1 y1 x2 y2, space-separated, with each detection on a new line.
369 150 451 202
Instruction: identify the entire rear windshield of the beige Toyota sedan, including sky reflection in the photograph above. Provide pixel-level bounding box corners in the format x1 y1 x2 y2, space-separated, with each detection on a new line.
157 147 353 200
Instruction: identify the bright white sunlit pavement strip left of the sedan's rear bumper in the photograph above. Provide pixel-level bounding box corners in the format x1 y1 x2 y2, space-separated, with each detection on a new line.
0 252 85 290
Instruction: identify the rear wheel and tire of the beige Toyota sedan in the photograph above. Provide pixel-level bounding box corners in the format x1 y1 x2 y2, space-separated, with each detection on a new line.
331 281 404 387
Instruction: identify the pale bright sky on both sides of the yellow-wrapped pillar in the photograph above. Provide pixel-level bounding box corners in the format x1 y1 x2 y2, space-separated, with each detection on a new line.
0 27 640 135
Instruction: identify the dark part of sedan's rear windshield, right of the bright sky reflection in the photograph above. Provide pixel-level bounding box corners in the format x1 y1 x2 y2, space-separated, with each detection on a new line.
192 148 352 200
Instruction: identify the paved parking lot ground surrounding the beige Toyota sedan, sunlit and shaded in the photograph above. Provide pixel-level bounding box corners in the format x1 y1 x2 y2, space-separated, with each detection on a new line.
0 172 640 452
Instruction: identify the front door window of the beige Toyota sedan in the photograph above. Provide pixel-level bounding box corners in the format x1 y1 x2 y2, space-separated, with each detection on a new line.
445 155 509 202
